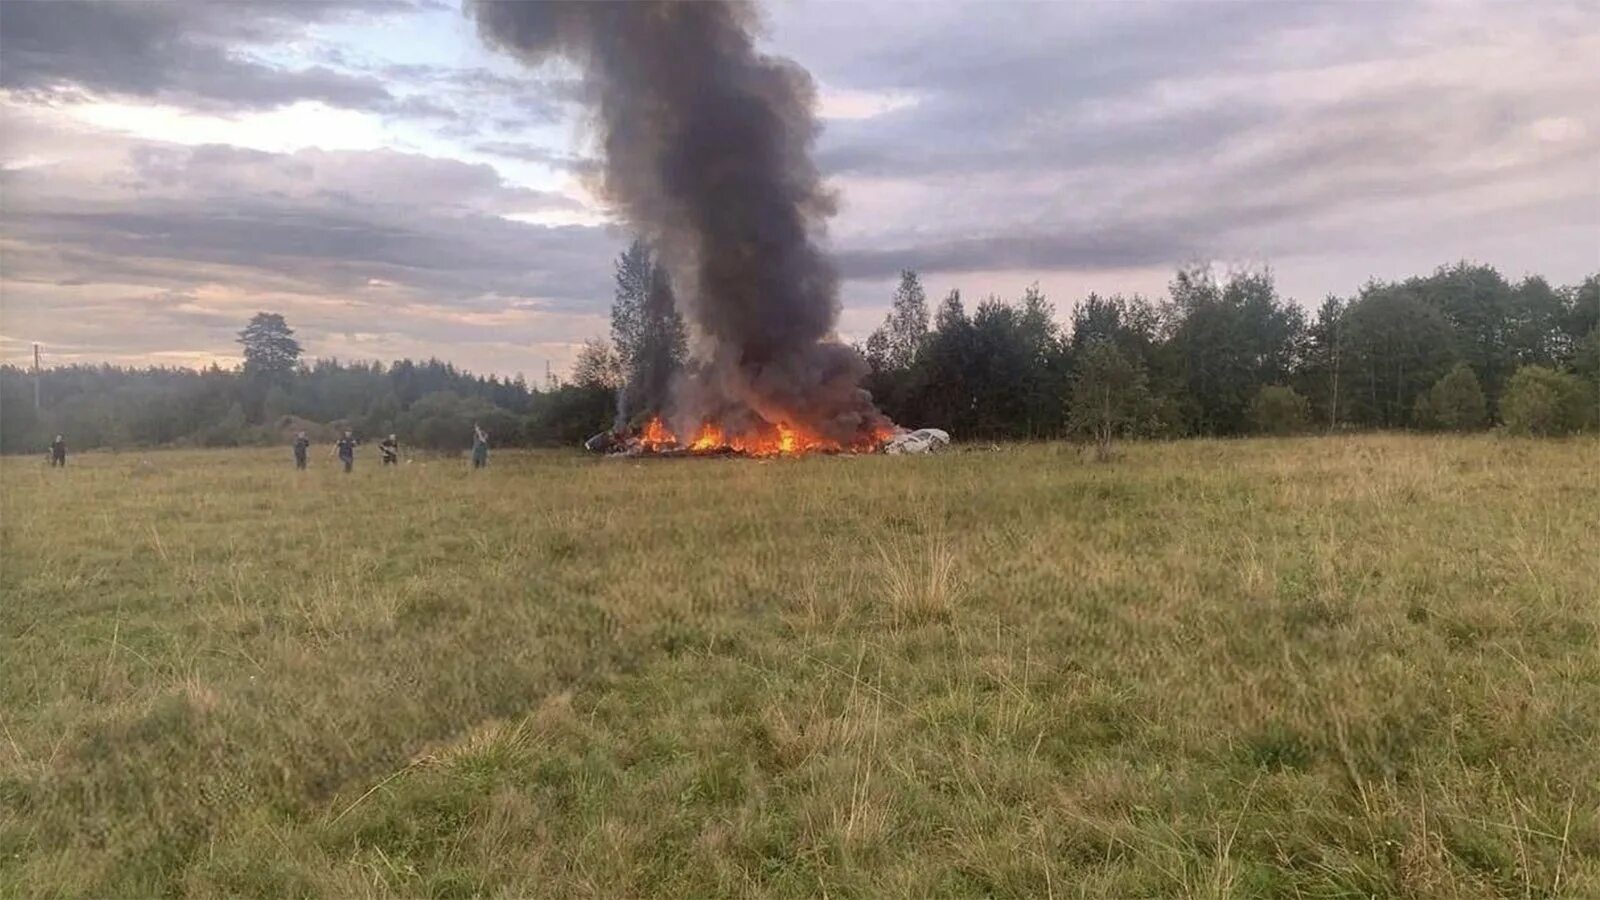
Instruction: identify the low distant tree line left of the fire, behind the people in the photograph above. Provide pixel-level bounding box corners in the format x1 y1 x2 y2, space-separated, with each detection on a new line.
0 312 604 453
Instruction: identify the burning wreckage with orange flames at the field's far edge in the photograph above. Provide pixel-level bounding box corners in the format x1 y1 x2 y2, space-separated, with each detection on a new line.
584 416 950 458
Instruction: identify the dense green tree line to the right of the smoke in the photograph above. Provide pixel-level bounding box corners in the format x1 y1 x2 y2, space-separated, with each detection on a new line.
862 263 1600 439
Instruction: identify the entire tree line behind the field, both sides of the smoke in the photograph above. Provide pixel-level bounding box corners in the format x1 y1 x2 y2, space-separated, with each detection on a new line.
0 254 1600 453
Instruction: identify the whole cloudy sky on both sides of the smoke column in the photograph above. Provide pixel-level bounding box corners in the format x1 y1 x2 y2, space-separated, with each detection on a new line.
0 0 1600 376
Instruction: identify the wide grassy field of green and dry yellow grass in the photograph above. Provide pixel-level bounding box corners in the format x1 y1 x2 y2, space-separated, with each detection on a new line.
0 436 1600 897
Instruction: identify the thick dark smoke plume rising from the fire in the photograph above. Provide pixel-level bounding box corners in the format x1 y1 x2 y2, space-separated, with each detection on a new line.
472 0 886 442
